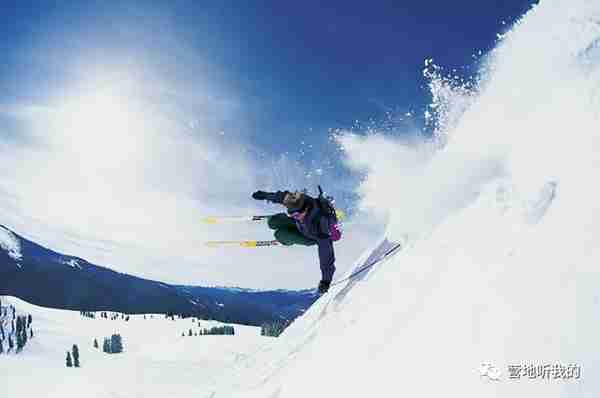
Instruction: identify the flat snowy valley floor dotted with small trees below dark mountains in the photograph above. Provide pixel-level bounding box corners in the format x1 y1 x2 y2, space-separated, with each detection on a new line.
0 297 270 397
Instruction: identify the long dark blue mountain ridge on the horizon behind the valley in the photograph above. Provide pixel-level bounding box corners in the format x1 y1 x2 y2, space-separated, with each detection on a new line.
0 225 316 325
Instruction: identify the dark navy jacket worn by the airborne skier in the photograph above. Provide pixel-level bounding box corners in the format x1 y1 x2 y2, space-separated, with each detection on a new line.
265 191 335 282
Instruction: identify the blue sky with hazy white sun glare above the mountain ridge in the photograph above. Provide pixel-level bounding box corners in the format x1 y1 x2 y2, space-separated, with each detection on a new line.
0 0 532 286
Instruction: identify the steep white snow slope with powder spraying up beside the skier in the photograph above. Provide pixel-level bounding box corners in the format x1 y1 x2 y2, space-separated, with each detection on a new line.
214 0 600 398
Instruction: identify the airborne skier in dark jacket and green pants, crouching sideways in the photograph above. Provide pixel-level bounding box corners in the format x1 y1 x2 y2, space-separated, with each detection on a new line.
252 187 341 294
